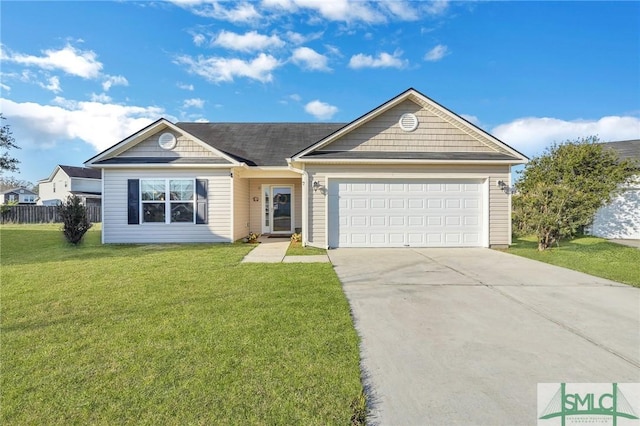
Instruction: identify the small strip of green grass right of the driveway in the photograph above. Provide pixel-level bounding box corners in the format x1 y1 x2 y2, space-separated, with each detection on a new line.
505 237 640 287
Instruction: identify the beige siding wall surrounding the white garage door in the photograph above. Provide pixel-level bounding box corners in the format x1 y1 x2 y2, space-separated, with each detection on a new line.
306 164 510 248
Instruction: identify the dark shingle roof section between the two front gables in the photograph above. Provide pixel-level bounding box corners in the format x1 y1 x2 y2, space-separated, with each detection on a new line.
176 123 346 166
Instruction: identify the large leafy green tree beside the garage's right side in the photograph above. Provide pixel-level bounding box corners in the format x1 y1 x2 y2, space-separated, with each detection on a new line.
513 136 637 251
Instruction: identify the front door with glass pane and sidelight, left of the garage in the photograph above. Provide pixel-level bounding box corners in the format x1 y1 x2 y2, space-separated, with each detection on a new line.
262 185 293 234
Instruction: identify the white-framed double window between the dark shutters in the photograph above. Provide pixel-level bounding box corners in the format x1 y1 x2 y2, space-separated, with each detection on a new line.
140 179 196 223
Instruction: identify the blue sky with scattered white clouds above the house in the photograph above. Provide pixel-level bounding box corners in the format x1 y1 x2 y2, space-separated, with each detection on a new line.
0 0 640 183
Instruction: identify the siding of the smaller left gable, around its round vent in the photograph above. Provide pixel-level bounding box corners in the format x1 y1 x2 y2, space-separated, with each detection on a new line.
118 129 225 158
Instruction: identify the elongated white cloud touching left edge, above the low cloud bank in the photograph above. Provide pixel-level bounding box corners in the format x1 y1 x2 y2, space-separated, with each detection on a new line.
0 44 102 79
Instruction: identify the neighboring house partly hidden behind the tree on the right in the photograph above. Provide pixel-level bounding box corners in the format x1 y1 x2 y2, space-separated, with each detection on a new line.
588 139 640 240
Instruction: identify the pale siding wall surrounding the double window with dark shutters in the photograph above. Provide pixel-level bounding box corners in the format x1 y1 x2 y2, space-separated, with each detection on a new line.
102 169 232 243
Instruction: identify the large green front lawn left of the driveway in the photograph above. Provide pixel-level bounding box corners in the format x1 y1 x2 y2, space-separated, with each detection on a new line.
0 225 362 425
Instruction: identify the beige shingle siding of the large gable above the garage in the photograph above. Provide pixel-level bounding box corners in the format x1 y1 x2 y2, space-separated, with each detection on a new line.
320 100 504 152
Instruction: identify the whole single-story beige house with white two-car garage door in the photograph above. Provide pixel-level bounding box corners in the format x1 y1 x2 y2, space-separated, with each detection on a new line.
85 89 527 248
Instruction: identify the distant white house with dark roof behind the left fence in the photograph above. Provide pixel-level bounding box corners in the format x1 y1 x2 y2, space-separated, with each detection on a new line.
38 165 102 206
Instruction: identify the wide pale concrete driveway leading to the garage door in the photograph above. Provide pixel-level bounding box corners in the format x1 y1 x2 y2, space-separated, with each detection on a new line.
329 248 640 425
